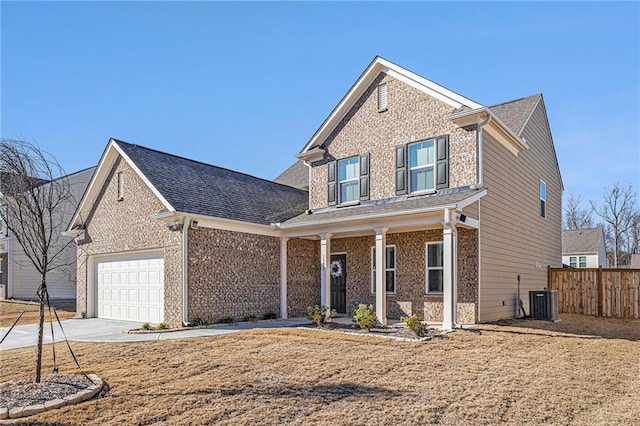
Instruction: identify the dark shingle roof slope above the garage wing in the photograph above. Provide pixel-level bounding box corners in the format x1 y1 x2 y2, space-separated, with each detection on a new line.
114 139 309 225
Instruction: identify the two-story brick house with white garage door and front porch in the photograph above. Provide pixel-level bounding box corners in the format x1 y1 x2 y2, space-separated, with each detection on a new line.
69 57 563 328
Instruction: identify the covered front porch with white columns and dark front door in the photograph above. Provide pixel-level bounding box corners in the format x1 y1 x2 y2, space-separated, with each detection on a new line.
280 193 478 329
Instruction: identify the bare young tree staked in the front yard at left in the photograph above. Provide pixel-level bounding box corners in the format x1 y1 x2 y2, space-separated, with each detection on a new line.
0 139 74 382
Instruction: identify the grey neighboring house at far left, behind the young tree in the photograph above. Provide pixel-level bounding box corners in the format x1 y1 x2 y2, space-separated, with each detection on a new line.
0 167 95 299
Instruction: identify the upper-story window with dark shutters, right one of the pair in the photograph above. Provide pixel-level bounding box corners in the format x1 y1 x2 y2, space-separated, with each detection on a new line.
396 135 449 195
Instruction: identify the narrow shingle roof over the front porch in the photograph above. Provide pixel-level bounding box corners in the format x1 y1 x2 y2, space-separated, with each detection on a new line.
282 187 482 228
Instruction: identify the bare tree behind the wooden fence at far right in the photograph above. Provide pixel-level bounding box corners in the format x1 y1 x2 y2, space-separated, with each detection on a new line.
589 183 639 268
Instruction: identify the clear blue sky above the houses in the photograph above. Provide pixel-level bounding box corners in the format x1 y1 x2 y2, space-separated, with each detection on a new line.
0 1 640 208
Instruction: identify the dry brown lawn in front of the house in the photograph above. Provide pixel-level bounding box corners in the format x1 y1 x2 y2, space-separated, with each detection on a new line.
0 315 640 425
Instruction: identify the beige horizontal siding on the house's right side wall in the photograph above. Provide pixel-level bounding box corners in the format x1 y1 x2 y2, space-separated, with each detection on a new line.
479 101 562 321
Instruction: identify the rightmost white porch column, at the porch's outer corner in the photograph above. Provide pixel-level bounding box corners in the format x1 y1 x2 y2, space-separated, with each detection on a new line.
442 209 457 330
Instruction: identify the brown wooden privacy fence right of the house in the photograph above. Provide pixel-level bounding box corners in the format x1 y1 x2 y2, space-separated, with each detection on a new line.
548 268 640 318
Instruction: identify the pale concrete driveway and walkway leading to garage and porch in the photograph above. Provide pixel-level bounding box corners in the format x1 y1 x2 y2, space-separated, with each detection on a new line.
0 318 309 351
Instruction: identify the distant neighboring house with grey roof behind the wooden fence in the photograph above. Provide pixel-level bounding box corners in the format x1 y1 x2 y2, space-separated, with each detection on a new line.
562 226 608 268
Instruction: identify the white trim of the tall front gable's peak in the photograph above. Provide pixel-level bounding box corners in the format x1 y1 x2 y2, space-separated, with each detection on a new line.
300 56 482 153
